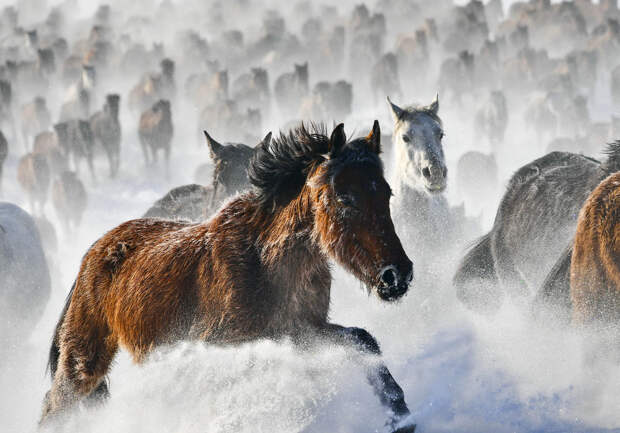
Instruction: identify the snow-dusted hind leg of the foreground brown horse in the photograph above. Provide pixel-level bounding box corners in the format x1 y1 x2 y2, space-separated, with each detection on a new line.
41 324 118 423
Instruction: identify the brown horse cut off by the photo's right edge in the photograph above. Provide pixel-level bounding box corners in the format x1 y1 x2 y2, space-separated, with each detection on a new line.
570 172 620 324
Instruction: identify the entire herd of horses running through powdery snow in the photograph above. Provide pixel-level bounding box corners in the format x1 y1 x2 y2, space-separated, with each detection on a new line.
0 0 620 433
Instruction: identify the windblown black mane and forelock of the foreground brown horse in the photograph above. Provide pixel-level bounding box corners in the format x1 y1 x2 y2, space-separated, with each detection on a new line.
248 123 382 209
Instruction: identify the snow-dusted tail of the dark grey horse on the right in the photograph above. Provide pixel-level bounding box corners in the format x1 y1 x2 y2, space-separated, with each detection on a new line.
452 232 501 310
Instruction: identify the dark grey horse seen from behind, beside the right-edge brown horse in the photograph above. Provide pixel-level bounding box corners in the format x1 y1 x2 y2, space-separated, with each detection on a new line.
453 142 620 312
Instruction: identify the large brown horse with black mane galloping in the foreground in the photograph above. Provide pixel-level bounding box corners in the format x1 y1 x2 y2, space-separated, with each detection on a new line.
42 121 415 432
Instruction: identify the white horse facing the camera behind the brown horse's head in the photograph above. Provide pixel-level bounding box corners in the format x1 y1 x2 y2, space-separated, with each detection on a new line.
388 96 478 272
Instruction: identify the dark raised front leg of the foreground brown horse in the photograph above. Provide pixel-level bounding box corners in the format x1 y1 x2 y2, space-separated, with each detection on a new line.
324 324 415 433
